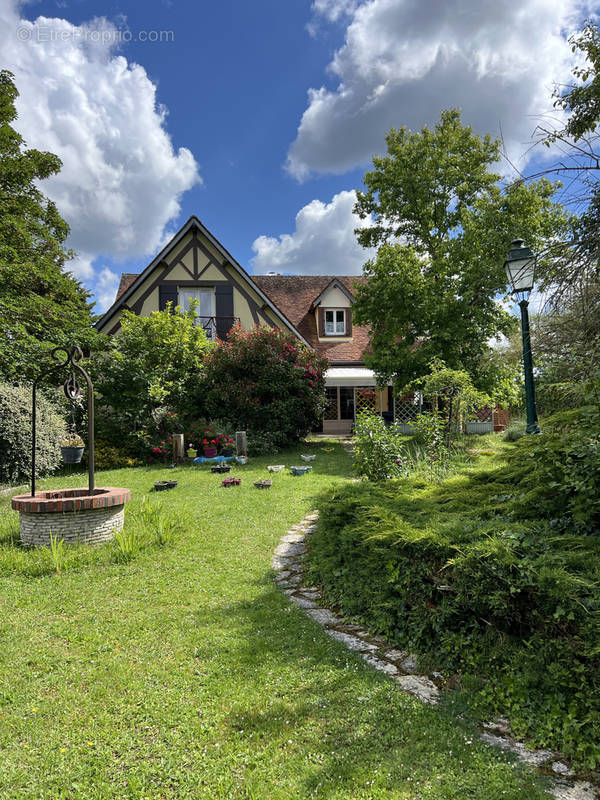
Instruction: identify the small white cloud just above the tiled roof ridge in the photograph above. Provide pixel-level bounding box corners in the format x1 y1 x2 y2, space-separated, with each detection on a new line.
252 192 375 275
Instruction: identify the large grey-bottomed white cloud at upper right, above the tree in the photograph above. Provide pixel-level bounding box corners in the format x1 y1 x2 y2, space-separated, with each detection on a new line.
286 0 589 180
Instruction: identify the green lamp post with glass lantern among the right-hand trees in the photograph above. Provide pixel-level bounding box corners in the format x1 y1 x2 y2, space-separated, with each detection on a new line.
504 239 540 433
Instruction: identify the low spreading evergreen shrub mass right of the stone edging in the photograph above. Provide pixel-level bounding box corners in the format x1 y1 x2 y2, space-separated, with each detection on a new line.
309 428 600 768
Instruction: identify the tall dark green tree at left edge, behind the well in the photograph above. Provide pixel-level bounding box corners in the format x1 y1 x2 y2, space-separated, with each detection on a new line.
0 70 97 382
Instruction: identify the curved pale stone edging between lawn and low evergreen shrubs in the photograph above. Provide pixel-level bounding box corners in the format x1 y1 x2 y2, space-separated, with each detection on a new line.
271 511 599 800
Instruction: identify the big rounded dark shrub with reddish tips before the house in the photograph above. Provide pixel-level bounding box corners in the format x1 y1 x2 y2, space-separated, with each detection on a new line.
196 325 326 447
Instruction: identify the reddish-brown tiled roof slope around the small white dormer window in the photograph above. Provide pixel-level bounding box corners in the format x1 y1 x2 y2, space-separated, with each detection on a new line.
251 275 370 362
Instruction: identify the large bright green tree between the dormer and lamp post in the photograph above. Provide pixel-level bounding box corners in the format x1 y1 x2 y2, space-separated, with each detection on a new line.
354 110 569 392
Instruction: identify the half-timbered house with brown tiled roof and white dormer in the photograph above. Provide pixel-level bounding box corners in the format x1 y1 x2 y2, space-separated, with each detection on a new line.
97 216 393 433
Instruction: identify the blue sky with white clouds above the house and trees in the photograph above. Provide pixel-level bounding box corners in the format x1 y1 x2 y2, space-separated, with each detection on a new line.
0 0 600 312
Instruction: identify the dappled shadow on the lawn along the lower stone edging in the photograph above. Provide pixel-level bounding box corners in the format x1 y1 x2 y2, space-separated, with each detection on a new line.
186 574 544 800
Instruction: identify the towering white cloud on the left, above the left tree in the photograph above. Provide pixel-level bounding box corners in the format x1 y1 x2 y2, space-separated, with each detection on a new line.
0 0 199 270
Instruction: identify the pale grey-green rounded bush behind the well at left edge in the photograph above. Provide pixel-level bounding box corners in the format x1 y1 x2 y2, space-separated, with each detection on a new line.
0 383 66 483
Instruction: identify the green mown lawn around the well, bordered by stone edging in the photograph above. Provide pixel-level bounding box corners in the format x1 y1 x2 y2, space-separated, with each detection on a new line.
0 441 546 800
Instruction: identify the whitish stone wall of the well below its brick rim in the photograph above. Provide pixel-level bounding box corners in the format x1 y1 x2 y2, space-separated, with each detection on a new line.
19 505 125 547
